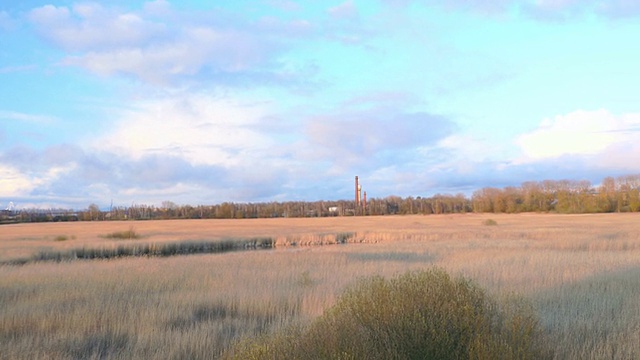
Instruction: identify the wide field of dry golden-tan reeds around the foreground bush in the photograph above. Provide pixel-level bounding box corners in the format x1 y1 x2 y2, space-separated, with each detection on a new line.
0 214 640 359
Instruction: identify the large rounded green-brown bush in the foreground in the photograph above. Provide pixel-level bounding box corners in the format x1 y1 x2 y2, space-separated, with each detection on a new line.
229 270 545 359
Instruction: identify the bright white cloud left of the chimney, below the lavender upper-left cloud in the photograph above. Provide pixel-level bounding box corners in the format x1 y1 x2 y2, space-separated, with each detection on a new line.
93 95 273 167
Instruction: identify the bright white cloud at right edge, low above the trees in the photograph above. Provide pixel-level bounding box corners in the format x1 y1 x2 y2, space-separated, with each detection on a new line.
517 110 640 162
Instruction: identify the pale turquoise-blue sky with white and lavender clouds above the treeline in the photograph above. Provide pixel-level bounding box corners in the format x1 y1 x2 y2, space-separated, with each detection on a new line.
0 0 640 209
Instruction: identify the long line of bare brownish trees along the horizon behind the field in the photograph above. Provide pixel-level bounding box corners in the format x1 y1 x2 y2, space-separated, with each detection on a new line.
0 174 640 223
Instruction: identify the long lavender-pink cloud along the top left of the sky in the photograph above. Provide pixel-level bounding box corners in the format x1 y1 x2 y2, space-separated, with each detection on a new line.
28 0 359 87
